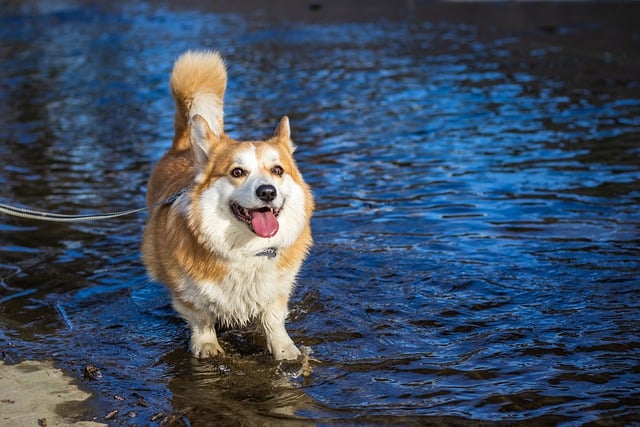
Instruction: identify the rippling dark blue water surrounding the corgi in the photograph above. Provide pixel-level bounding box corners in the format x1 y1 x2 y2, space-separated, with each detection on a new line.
0 2 640 425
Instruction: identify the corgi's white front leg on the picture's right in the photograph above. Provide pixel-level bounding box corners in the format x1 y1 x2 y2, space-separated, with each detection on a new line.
261 297 301 360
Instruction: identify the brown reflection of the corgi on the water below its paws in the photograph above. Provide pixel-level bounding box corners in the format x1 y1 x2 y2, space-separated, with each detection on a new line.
164 330 318 425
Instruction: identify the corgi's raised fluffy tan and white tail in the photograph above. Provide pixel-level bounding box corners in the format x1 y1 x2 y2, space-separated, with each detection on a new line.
170 51 227 150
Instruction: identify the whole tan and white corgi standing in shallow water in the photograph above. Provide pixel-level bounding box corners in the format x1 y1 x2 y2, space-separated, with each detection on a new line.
142 51 314 360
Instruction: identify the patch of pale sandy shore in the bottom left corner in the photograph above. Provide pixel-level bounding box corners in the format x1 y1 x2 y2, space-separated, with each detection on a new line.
0 361 106 427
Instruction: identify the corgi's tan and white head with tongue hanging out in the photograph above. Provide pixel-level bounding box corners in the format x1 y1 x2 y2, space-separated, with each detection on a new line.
189 115 312 254
